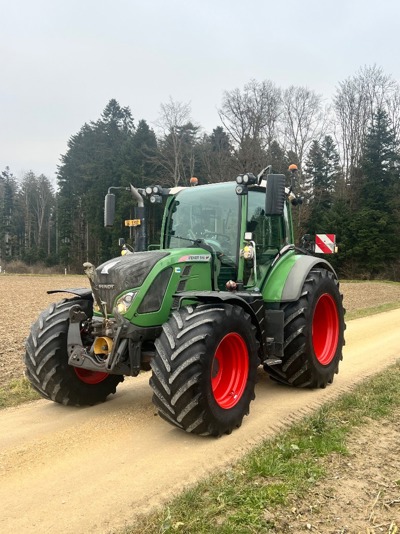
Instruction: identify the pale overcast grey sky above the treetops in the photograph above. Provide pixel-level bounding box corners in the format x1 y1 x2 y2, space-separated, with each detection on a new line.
0 0 400 184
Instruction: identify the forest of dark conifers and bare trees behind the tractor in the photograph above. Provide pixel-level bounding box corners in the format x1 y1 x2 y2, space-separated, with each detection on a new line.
0 65 400 280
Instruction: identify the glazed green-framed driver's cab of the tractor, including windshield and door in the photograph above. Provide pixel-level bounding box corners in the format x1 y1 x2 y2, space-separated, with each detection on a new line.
161 182 293 290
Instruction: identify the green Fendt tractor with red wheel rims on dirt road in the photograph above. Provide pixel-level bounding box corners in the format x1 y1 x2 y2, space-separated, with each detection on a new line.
25 168 345 436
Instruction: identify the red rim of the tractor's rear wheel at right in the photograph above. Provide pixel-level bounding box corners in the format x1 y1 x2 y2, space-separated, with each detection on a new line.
312 293 339 365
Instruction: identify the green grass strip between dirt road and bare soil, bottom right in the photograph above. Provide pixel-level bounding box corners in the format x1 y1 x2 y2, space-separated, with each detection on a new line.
119 362 400 534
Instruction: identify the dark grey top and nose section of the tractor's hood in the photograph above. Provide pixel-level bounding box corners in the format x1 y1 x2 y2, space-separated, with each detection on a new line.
93 250 169 313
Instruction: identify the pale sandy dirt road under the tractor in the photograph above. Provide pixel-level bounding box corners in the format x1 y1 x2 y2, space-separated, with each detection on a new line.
0 310 400 534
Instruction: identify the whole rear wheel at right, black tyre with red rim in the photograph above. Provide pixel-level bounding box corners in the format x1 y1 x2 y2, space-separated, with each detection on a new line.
264 268 345 388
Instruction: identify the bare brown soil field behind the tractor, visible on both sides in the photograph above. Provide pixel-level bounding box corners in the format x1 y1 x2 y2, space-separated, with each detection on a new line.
0 275 400 387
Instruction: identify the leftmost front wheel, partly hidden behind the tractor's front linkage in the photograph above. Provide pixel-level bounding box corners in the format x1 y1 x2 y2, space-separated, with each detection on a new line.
25 298 124 406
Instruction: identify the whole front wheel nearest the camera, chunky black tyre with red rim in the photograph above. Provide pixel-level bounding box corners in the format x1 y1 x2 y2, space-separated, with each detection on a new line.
150 304 260 436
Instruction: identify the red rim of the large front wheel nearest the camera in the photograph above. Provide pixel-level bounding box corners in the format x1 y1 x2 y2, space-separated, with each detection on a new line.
211 332 249 410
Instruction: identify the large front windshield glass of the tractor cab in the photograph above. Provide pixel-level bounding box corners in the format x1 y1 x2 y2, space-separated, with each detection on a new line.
166 182 239 263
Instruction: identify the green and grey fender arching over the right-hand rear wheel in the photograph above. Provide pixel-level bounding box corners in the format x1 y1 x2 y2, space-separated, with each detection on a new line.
262 254 337 302
